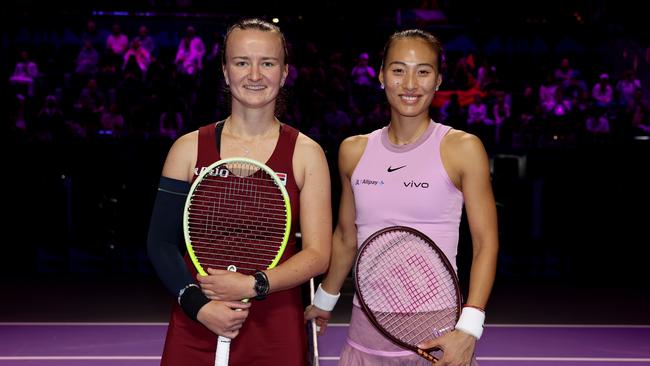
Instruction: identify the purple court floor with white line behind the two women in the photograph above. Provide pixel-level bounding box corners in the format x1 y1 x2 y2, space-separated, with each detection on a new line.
0 323 650 366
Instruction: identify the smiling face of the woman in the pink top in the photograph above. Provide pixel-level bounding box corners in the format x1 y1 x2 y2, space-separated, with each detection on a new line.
379 37 442 119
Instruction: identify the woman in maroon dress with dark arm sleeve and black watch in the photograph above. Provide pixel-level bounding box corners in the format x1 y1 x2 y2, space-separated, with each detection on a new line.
148 19 332 366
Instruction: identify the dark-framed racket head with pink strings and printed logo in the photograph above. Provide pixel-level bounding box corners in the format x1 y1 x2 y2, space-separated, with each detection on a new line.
354 226 461 359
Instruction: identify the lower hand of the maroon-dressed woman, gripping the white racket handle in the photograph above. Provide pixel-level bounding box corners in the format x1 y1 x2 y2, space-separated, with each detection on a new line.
197 300 251 339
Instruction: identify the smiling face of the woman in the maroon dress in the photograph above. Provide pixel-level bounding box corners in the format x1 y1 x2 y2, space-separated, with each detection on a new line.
223 29 287 108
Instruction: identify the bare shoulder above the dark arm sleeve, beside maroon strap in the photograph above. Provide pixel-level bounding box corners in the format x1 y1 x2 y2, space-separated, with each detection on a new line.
162 131 199 181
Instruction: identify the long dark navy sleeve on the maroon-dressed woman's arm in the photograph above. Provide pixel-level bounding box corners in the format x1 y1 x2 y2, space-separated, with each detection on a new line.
147 177 196 297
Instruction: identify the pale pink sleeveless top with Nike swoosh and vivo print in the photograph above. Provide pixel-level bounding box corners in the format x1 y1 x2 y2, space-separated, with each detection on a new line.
351 121 463 269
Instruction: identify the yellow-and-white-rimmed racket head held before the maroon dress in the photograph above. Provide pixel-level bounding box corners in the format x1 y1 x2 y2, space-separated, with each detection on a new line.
183 157 291 275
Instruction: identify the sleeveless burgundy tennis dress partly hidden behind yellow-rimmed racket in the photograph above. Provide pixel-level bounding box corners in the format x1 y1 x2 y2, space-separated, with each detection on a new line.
161 124 307 366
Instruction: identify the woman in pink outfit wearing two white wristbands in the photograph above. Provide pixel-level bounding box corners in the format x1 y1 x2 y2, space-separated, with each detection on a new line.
305 30 498 366
